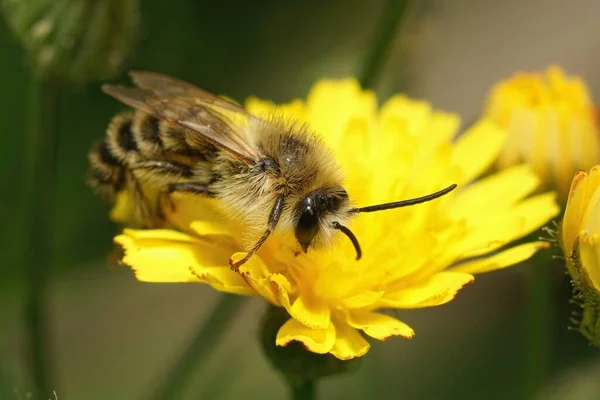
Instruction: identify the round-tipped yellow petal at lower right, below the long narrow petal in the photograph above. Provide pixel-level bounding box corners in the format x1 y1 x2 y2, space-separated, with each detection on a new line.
379 271 474 308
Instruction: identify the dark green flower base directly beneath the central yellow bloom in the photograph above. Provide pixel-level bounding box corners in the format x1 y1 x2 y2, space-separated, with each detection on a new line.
260 306 361 387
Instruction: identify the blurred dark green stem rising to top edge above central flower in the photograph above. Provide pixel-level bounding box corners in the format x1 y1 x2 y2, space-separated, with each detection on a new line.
359 0 410 89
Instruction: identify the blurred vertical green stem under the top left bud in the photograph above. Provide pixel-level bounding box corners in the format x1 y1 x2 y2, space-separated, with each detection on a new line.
22 73 61 398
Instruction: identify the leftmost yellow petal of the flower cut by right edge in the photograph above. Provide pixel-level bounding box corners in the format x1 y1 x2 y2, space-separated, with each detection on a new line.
561 171 588 257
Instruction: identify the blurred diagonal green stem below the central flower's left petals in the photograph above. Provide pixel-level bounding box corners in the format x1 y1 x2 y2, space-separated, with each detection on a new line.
151 294 244 400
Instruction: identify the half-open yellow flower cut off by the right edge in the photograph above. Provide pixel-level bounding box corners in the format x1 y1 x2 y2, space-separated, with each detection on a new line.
560 165 600 346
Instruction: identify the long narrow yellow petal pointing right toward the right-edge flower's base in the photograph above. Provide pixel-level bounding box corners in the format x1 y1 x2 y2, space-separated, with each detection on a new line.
452 242 550 275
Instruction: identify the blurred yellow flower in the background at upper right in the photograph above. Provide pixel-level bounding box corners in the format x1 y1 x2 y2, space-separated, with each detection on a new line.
485 67 600 197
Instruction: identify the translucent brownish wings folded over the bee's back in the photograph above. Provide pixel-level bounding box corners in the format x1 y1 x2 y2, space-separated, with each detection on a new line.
102 73 262 164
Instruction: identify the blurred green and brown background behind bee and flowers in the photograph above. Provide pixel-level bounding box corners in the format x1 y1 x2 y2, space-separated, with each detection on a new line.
0 0 600 400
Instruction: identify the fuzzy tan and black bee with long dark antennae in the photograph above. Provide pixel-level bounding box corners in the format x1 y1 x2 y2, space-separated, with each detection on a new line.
90 72 456 271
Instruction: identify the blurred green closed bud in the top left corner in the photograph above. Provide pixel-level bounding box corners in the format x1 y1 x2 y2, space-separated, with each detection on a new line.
0 0 140 83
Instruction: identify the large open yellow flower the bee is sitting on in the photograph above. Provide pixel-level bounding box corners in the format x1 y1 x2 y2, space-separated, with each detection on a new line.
116 80 558 359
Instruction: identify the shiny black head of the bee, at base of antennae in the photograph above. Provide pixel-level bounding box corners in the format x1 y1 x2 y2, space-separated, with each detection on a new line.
294 187 349 253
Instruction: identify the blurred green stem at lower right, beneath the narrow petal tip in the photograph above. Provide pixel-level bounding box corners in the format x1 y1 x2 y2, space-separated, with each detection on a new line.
523 252 554 399
